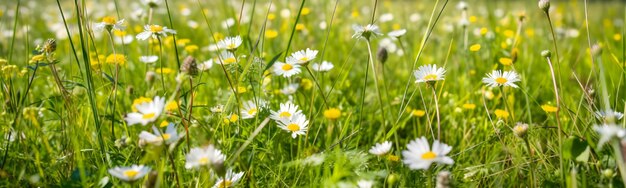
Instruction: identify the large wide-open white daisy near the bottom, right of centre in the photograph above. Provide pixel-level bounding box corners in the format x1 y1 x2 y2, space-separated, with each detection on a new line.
402 136 454 170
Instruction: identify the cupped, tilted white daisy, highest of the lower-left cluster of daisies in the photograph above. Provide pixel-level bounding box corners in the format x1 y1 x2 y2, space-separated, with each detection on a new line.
124 96 165 125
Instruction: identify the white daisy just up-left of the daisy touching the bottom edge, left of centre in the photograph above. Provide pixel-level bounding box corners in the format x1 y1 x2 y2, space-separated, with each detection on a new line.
185 145 226 169
